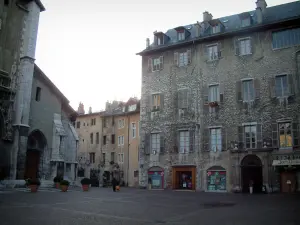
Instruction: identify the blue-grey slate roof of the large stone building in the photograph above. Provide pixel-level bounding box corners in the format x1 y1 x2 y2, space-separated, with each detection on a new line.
137 1 300 55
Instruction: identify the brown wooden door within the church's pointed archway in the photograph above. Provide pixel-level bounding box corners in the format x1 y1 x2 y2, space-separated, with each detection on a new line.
24 150 40 179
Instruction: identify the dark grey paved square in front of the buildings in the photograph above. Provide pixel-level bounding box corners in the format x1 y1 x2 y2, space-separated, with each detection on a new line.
0 188 300 225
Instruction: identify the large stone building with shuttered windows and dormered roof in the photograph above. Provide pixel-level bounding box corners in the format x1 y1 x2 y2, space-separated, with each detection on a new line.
138 0 300 192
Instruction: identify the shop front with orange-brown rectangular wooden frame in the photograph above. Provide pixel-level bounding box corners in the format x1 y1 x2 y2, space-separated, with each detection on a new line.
172 166 196 190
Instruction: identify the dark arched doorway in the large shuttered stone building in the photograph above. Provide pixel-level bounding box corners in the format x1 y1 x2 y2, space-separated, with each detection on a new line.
241 155 263 193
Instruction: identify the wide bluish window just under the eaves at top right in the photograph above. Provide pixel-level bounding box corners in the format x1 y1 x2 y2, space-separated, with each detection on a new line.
272 28 300 49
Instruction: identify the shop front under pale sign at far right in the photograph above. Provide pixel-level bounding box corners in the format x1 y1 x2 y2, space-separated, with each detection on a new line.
272 154 300 193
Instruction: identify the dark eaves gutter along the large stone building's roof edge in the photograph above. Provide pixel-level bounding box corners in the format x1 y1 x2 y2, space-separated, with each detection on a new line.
136 16 300 56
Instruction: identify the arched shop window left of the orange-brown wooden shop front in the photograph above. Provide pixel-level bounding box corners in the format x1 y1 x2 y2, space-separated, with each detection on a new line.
148 166 164 189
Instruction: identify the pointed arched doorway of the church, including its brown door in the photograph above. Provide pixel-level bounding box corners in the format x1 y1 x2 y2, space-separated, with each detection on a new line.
24 130 47 179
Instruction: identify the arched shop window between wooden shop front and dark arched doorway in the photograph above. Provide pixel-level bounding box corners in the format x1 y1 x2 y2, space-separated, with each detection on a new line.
207 166 226 192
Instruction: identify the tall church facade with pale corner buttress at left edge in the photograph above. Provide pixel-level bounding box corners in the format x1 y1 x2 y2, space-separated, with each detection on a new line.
0 0 45 179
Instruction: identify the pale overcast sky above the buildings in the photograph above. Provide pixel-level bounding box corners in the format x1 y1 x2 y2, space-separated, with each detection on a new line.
36 0 293 112
